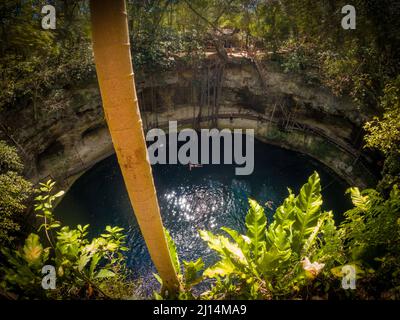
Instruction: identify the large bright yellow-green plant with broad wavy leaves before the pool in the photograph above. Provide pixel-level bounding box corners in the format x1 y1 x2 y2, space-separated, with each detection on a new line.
200 173 340 299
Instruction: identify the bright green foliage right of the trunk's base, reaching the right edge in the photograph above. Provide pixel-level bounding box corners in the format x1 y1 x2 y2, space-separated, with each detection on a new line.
156 173 400 299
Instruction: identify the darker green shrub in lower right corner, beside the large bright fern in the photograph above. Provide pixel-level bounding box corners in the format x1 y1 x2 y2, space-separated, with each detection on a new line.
341 186 400 299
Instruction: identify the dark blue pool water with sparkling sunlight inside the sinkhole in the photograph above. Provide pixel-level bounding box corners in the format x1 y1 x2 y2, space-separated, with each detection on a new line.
56 136 350 296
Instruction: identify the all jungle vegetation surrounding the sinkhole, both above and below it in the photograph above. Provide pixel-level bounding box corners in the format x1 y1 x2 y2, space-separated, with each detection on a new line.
0 0 400 299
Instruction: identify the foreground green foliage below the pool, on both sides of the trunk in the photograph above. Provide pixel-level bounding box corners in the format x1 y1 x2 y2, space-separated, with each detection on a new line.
0 173 394 300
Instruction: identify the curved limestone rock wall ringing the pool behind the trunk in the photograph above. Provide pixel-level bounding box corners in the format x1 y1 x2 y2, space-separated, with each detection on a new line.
0 57 375 188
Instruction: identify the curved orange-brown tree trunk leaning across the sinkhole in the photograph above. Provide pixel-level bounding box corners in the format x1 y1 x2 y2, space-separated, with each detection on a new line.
90 0 179 294
